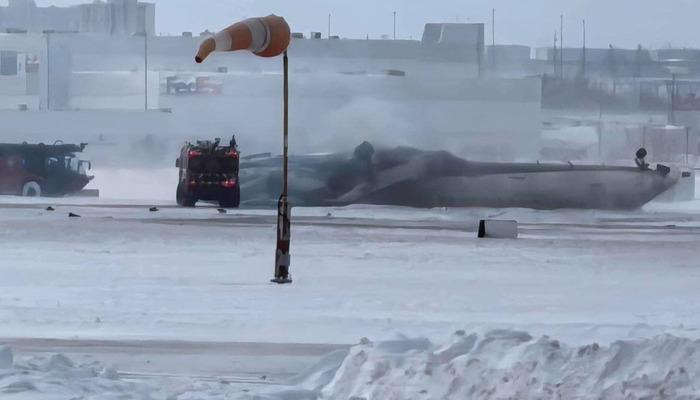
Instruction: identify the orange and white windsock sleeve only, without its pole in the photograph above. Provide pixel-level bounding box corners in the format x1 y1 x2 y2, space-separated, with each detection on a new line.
195 15 292 63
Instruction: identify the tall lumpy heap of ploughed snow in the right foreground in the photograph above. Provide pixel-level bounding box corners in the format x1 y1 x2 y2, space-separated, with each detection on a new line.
294 330 700 400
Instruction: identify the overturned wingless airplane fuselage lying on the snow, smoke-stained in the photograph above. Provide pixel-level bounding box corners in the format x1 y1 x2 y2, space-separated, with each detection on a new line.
241 142 678 210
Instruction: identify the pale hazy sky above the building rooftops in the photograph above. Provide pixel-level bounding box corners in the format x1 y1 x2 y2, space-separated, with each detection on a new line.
9 0 700 47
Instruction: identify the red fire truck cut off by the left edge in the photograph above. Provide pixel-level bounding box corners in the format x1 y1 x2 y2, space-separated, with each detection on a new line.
0 141 94 197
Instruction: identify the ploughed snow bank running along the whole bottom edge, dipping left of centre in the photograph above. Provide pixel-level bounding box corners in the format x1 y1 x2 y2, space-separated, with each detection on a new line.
0 330 700 400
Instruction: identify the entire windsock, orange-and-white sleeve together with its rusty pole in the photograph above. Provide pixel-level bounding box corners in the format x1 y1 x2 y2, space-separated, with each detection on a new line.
195 15 292 284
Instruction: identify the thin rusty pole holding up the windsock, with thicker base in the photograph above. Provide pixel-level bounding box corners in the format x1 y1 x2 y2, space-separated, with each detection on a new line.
272 50 292 284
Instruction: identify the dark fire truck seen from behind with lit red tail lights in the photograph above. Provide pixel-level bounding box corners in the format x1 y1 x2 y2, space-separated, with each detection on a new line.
175 136 241 208
